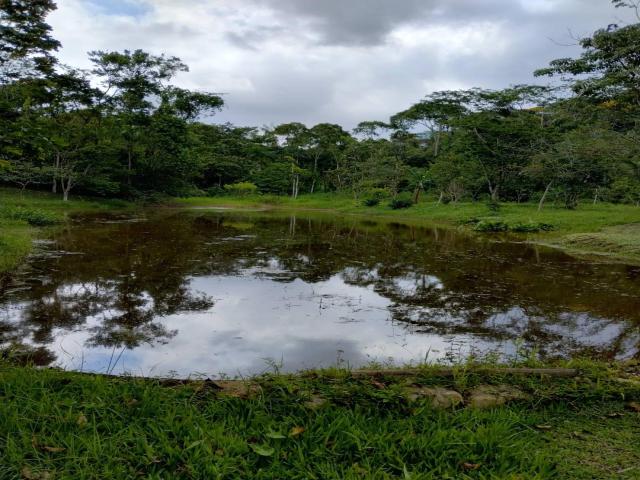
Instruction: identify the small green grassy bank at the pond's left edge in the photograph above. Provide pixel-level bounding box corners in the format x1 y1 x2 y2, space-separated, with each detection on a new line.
0 188 129 275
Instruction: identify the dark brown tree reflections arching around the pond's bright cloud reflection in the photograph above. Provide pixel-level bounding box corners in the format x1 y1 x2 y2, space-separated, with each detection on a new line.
5 212 640 366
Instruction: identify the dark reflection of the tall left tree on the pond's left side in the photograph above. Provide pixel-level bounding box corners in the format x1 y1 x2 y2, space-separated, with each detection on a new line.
0 218 213 364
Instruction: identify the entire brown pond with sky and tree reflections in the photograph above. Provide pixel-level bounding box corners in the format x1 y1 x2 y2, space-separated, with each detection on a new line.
0 210 640 377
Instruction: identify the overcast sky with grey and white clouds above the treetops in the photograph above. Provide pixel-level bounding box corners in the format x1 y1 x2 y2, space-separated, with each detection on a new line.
49 0 630 128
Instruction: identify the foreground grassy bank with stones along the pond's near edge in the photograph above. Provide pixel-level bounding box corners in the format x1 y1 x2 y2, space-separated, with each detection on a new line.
0 363 640 480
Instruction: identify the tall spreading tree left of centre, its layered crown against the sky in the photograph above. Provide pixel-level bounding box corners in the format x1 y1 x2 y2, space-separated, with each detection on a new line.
90 50 223 191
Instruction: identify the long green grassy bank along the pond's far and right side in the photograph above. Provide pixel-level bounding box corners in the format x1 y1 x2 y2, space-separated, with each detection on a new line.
175 194 640 263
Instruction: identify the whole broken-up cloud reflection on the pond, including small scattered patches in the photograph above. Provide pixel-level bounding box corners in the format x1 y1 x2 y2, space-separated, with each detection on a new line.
3 270 633 376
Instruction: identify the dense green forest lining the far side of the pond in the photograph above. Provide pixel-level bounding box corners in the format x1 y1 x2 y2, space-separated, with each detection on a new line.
0 0 640 208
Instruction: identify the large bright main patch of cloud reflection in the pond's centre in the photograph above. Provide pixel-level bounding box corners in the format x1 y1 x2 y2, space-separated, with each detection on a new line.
20 275 490 376
